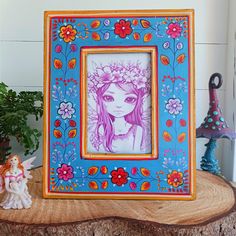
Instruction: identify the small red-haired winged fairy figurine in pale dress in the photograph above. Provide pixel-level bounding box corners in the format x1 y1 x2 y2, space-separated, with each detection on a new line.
0 154 36 209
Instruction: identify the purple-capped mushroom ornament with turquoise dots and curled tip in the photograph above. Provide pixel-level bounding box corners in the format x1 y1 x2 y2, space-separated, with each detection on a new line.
197 73 236 175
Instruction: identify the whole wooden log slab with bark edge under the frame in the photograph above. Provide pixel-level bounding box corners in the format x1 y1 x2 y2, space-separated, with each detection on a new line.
0 168 236 236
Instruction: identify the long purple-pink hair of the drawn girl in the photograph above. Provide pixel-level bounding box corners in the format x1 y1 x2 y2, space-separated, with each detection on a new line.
97 82 145 152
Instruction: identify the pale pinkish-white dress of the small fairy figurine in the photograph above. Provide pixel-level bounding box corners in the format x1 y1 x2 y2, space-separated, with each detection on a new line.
0 172 32 209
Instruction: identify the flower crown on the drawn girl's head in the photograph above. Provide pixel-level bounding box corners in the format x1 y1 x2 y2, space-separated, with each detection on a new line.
88 62 150 93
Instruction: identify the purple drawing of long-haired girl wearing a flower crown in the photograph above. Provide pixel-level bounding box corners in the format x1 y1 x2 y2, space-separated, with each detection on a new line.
88 62 151 153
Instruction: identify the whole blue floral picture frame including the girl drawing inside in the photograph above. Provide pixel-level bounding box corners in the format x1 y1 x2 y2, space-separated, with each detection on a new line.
43 10 196 200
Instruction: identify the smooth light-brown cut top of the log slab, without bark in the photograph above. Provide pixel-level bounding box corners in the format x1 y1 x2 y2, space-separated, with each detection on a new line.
0 168 235 235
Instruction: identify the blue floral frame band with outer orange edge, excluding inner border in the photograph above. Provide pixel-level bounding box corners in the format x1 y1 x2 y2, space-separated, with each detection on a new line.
43 10 196 200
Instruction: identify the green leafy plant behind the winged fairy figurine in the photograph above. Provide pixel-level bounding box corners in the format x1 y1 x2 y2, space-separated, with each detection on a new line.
0 83 43 164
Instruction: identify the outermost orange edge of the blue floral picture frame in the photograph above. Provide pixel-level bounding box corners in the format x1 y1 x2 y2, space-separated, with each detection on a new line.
43 9 196 200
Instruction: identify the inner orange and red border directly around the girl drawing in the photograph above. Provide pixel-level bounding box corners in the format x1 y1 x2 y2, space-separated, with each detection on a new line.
80 46 159 160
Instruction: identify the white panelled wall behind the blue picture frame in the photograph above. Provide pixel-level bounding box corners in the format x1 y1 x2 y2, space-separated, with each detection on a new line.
0 0 233 179
